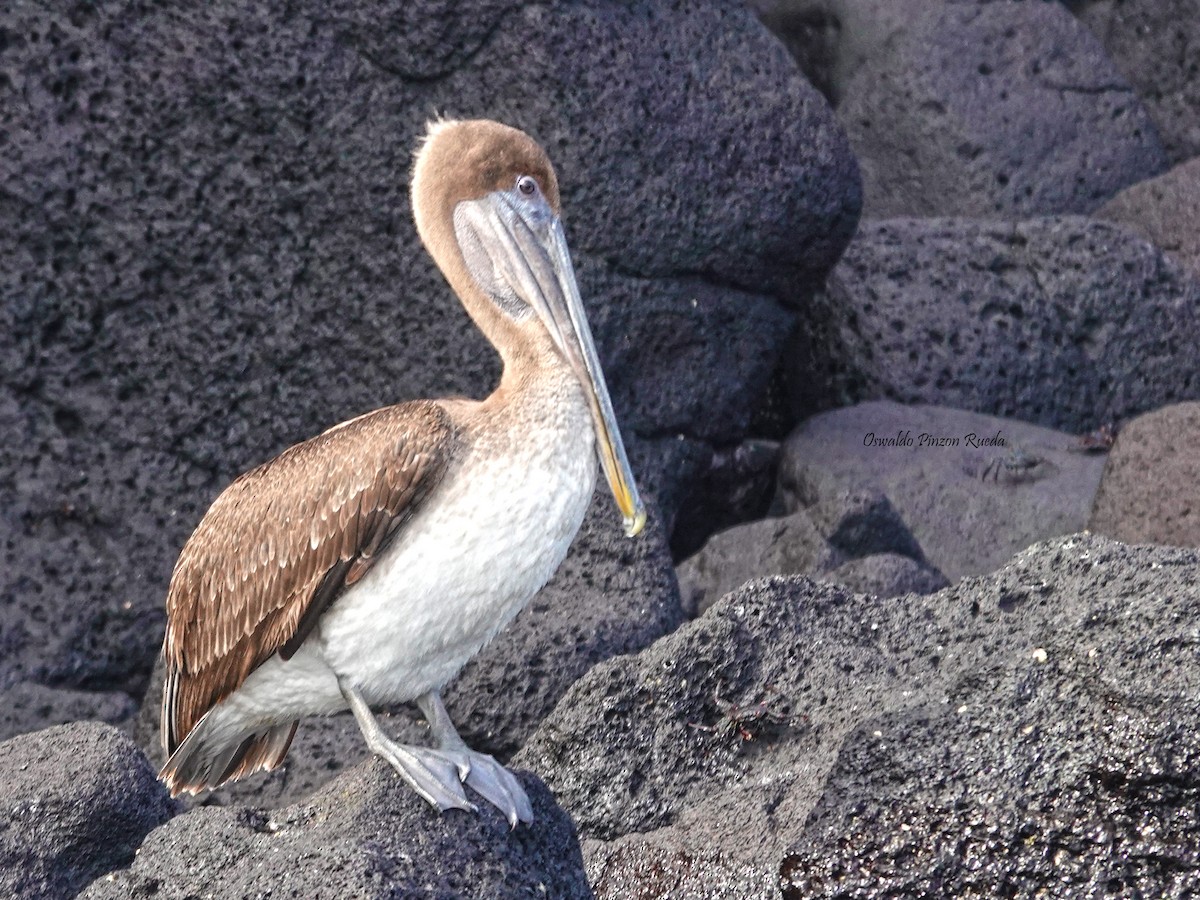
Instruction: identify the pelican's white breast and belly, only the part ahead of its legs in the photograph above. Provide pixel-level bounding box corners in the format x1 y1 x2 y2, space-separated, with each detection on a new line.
318 420 596 703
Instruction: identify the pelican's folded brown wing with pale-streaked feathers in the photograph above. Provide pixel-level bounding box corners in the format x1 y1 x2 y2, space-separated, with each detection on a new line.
162 402 456 754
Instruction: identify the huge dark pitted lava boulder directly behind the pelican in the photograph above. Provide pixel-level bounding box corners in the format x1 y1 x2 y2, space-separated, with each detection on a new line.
0 0 844 724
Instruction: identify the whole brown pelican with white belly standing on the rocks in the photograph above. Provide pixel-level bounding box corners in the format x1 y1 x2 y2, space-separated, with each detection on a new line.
160 121 646 826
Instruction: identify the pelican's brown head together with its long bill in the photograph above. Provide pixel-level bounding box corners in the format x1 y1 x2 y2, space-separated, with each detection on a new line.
412 120 646 536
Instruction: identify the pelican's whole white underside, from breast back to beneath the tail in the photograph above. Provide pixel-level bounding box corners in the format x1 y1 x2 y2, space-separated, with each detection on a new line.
222 397 596 722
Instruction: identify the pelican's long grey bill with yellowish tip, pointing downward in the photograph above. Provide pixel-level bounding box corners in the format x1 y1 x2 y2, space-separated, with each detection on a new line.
462 193 646 538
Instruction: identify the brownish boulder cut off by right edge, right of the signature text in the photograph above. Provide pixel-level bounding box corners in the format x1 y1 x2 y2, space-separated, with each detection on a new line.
1087 403 1200 547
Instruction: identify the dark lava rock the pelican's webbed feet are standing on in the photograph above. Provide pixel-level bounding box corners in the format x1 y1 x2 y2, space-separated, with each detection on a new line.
82 760 592 900
